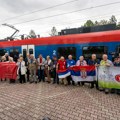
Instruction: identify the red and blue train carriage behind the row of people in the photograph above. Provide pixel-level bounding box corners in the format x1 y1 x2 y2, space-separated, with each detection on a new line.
0 30 120 60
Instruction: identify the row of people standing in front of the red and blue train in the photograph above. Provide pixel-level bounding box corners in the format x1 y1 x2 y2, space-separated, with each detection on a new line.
1 53 120 92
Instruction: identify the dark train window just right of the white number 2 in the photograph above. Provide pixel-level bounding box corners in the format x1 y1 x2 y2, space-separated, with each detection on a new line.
57 47 76 60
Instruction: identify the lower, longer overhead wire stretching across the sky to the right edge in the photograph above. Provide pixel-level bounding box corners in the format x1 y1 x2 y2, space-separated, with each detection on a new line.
13 1 120 25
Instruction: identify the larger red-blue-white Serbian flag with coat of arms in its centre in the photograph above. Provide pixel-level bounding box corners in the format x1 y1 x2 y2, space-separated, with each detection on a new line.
69 66 96 82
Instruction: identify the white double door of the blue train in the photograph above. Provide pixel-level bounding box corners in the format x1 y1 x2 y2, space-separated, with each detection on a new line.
22 45 35 58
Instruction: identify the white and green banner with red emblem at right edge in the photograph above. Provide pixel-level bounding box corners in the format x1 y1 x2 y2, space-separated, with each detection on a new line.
98 66 120 89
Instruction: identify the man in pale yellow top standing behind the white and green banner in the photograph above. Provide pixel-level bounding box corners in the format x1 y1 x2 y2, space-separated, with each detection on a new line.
100 54 113 94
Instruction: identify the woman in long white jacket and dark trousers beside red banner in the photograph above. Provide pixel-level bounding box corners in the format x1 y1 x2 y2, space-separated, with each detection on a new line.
17 57 26 84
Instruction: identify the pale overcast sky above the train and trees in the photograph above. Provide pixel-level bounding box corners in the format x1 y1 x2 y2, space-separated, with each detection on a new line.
0 0 120 39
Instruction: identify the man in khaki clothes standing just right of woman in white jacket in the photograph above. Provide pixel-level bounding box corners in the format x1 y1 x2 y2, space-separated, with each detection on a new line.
28 54 37 83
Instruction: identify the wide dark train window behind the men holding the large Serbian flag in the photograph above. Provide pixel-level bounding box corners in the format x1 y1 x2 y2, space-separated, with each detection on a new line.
82 46 108 59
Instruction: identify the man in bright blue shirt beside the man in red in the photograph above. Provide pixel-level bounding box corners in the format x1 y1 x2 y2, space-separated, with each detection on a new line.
67 55 75 85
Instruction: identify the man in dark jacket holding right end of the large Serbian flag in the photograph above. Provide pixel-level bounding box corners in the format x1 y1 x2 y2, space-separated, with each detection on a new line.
88 54 100 89
